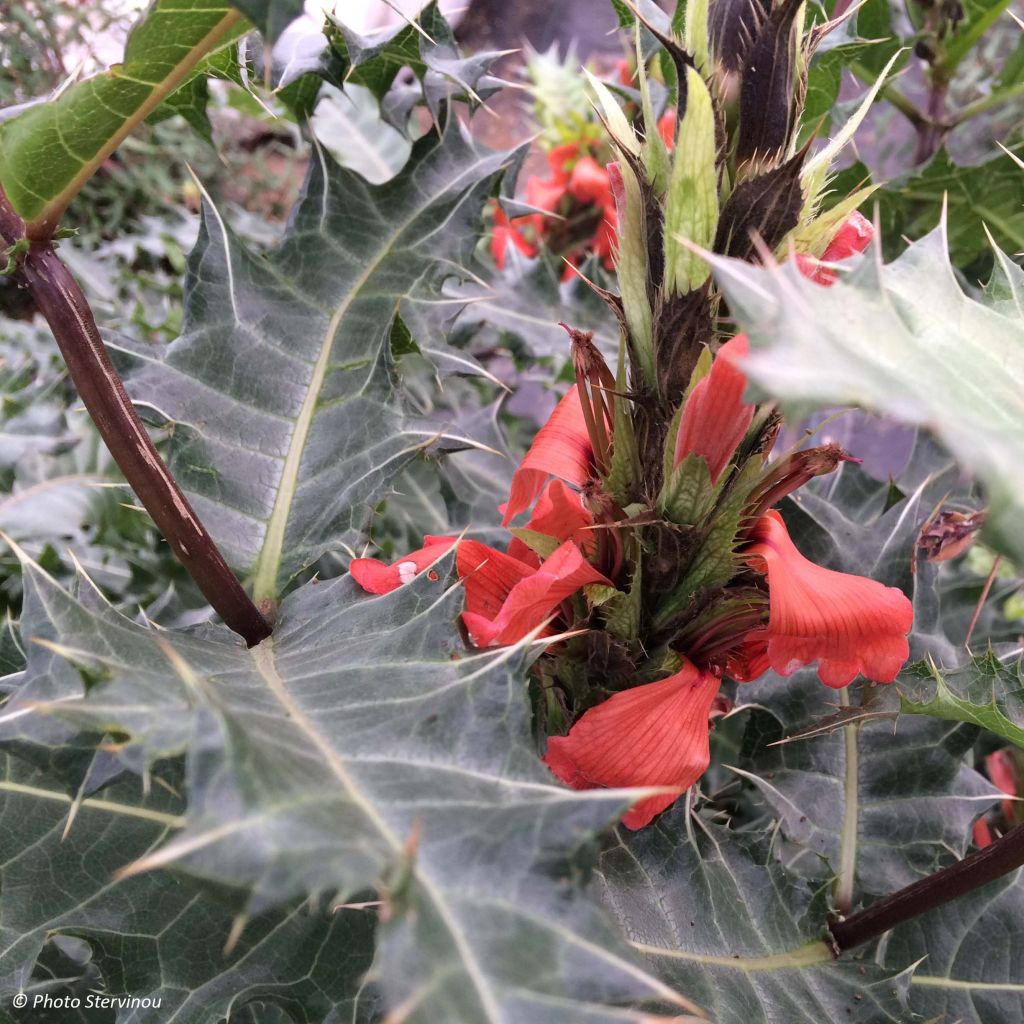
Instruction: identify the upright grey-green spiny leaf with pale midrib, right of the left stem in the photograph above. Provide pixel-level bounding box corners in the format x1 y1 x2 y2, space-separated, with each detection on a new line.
113 116 507 598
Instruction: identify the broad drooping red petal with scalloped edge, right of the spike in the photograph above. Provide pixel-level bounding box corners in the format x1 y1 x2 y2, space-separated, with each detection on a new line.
743 511 913 688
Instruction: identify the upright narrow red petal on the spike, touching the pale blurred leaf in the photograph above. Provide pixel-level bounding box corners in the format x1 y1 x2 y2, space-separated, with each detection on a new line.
676 334 755 482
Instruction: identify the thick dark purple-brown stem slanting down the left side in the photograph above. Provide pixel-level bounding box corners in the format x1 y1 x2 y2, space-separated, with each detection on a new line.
0 190 270 647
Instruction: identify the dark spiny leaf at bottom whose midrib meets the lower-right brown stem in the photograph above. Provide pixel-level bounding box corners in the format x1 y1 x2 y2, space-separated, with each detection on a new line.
600 808 907 1024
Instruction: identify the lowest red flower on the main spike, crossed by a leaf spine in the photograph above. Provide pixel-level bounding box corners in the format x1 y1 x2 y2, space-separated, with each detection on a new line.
544 662 721 828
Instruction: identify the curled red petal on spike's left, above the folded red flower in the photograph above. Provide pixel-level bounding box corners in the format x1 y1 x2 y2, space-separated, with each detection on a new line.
500 384 594 526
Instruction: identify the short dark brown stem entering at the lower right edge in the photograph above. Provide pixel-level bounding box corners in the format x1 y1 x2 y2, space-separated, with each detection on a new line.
828 825 1024 954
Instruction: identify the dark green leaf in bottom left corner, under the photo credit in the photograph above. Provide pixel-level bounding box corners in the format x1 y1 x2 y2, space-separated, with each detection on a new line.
0 751 375 1024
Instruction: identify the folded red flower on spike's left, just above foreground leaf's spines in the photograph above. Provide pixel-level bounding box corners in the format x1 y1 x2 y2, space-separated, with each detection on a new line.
456 541 610 647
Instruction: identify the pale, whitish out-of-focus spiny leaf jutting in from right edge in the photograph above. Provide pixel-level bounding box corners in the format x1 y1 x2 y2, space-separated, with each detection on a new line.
715 224 1024 560
